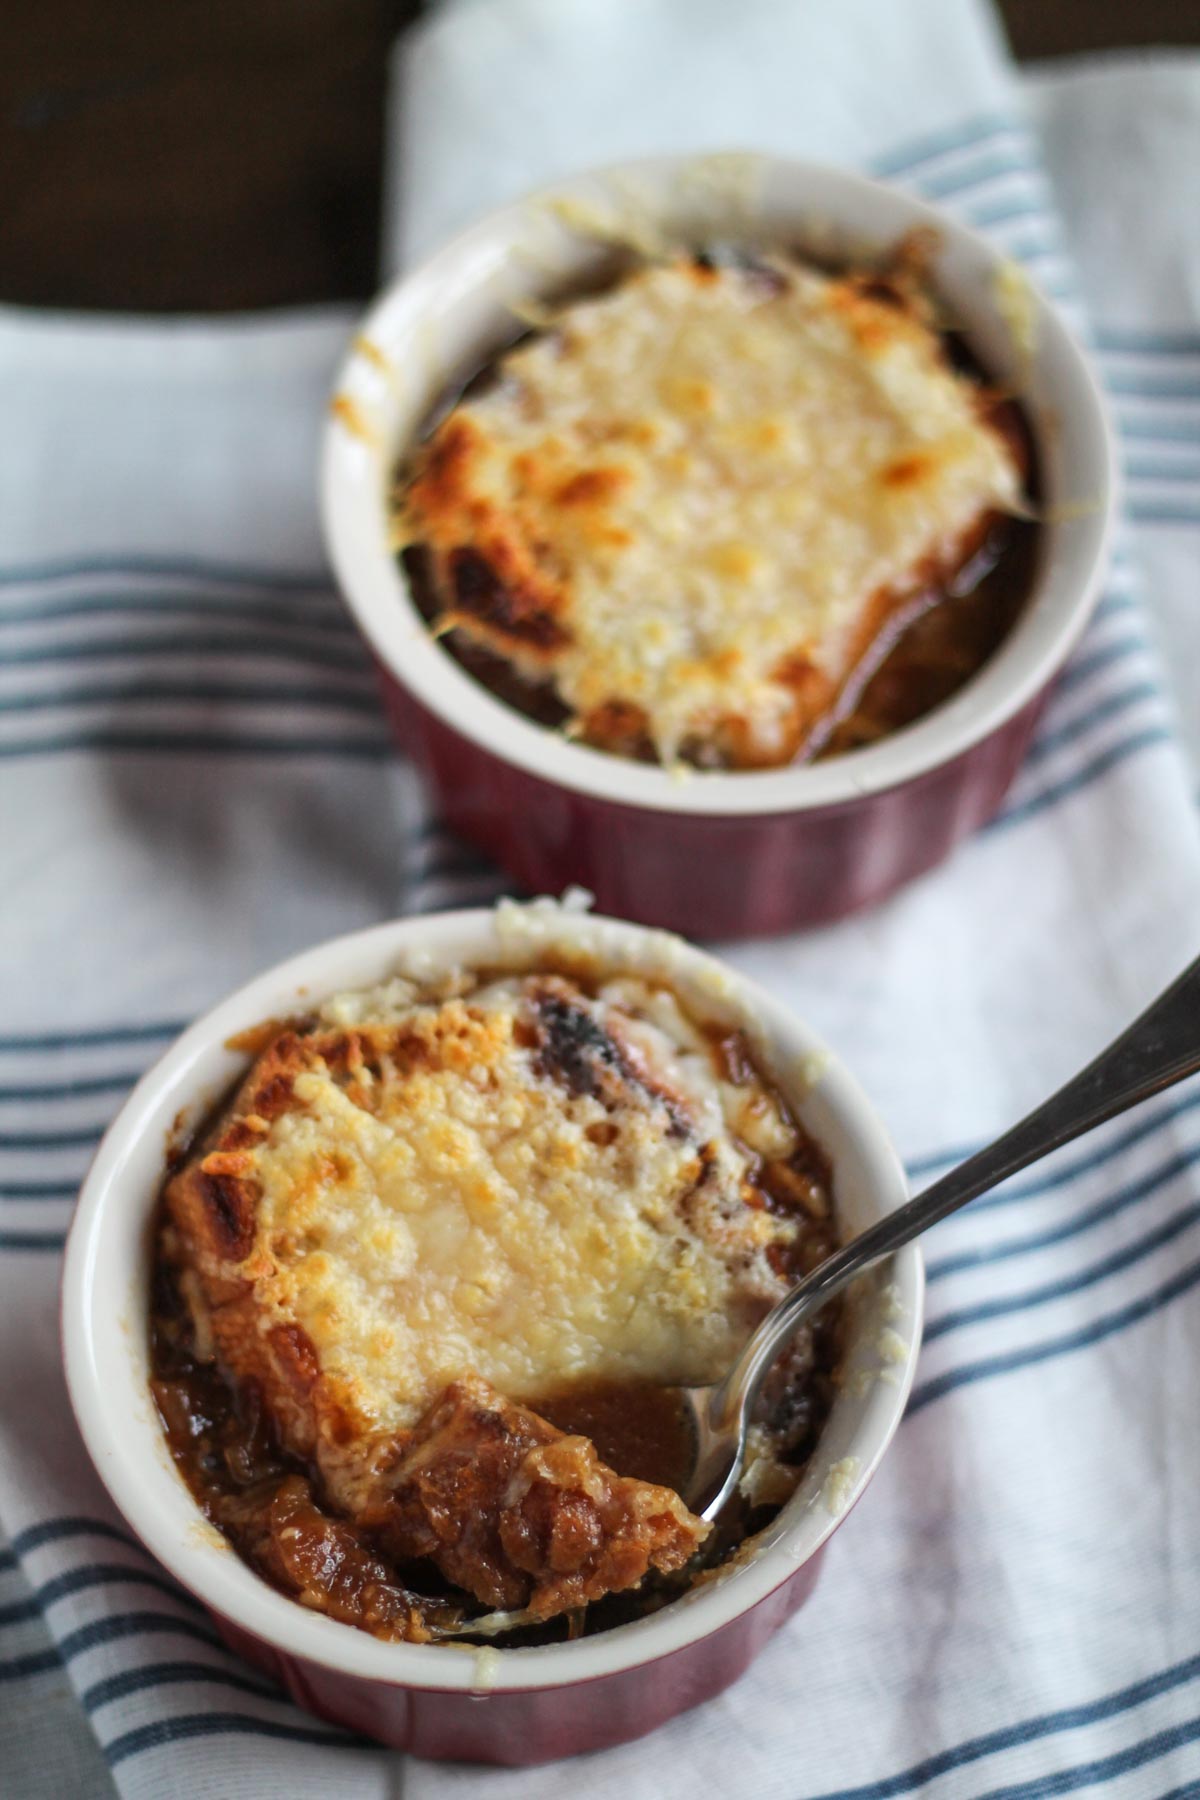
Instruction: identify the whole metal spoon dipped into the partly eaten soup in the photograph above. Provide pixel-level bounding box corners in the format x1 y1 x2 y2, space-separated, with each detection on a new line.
440 958 1200 1636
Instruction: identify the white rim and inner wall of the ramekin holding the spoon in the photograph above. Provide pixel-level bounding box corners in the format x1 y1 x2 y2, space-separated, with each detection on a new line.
63 902 923 1692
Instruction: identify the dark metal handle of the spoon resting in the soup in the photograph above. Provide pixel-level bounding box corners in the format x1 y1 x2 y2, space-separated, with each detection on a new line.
711 958 1200 1422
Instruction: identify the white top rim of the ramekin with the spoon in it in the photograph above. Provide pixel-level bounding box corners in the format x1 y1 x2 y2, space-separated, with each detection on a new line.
61 902 923 1692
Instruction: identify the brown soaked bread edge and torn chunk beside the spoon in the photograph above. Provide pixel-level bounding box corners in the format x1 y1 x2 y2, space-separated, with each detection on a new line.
164 1026 705 1636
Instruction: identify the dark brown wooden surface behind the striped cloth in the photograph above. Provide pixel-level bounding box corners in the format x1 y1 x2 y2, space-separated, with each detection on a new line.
0 0 1200 311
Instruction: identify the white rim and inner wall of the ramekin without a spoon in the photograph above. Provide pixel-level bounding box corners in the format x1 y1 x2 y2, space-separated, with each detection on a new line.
322 157 1115 815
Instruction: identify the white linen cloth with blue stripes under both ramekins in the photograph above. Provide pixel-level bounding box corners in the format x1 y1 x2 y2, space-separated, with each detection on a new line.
0 0 1200 1800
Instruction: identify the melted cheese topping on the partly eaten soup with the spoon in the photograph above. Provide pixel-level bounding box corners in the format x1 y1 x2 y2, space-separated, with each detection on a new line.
243 976 797 1429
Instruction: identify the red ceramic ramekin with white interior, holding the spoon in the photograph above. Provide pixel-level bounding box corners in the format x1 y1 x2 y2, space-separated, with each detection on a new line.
63 902 923 1764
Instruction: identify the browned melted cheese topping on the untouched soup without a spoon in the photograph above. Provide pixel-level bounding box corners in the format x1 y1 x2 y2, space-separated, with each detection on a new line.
396 261 1020 761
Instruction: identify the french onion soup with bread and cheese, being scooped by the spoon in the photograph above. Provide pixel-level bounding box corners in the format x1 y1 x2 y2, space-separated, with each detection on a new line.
151 959 840 1643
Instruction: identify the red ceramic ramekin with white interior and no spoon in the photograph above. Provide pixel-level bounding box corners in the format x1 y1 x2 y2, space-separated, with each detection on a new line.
322 157 1114 938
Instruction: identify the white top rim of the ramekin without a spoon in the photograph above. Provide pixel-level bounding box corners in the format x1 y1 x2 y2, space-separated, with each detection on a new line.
318 153 1119 817
